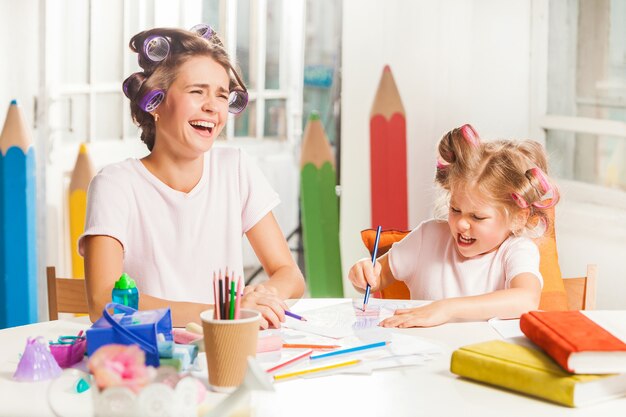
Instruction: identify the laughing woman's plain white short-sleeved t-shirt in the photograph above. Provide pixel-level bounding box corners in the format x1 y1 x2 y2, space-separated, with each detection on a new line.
78 147 280 303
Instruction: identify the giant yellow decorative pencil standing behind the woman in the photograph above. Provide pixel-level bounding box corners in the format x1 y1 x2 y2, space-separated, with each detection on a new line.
69 143 96 278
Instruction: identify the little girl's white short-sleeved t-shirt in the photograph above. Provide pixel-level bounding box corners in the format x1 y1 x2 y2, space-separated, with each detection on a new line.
389 220 543 300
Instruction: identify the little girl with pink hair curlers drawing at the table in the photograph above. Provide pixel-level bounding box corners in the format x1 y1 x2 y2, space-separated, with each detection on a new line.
349 125 559 327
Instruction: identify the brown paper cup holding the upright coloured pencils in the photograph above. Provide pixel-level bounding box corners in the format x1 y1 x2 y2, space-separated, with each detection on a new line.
200 308 261 392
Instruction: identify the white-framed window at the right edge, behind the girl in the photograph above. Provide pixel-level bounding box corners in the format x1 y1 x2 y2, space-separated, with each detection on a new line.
540 0 626 191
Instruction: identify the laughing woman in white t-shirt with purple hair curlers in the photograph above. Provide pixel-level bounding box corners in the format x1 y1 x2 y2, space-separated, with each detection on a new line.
79 25 304 328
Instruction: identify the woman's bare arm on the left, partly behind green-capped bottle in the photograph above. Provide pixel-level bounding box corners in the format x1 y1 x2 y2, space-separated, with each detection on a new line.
84 235 212 327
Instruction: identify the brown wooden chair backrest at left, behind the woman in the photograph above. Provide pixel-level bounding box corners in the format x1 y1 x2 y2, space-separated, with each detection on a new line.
46 266 89 320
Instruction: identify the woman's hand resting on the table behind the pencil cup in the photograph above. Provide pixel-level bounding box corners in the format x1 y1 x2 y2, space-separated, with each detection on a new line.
241 284 288 329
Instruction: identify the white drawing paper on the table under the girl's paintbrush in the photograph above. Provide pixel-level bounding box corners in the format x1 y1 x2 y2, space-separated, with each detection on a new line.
283 299 425 339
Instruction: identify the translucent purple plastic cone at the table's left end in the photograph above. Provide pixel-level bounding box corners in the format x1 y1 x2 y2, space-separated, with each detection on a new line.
13 336 63 382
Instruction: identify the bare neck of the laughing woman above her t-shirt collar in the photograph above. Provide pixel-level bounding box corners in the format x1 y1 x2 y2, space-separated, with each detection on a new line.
141 150 204 193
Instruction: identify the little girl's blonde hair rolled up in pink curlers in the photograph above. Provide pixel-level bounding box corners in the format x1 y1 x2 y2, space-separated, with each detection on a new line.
435 125 559 233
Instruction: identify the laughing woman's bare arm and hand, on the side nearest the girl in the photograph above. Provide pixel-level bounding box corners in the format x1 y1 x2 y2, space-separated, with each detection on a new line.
242 212 305 328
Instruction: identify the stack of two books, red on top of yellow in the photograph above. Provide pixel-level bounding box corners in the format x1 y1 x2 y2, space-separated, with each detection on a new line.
450 311 626 407
